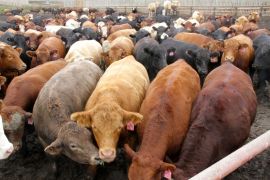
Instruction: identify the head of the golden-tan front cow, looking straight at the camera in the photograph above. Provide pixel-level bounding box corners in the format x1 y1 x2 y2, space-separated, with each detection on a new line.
71 103 143 162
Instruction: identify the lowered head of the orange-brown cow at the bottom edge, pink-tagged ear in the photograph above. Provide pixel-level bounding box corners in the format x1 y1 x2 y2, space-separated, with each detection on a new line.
125 144 176 180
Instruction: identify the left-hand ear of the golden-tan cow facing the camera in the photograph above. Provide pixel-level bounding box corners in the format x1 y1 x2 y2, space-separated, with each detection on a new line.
70 111 92 128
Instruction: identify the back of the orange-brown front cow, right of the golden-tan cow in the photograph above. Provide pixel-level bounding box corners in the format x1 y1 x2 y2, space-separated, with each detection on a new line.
139 60 200 153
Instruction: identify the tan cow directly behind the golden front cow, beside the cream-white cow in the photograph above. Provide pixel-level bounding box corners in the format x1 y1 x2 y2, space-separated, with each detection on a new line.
102 36 134 67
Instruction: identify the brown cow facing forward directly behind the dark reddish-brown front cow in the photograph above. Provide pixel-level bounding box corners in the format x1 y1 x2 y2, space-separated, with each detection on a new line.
221 34 254 72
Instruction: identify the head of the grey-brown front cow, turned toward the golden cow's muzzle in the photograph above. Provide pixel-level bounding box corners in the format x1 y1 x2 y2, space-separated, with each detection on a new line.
44 121 101 165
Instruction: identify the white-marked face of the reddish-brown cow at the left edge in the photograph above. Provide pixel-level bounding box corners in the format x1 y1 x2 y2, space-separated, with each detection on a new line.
0 100 32 151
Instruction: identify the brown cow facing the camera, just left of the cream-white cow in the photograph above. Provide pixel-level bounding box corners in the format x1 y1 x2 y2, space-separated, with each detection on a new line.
26 37 66 68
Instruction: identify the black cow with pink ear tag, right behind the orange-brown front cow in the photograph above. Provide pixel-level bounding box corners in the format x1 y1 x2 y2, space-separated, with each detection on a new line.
161 38 210 84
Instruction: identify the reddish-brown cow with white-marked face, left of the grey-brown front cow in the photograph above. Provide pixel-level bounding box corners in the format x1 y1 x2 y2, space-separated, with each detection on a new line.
0 60 66 151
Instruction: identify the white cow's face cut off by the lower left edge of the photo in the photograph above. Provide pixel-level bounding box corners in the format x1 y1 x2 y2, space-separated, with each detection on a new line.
0 116 14 160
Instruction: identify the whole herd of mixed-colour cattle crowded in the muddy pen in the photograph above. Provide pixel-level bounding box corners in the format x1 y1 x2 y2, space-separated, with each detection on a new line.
0 3 270 180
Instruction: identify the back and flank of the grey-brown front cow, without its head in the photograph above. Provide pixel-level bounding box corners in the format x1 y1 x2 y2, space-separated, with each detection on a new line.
33 61 102 143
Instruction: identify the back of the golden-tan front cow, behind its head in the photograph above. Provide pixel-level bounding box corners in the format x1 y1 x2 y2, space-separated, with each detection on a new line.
85 56 149 111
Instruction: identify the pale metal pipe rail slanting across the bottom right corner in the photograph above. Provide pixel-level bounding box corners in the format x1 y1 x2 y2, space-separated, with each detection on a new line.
190 130 270 180
